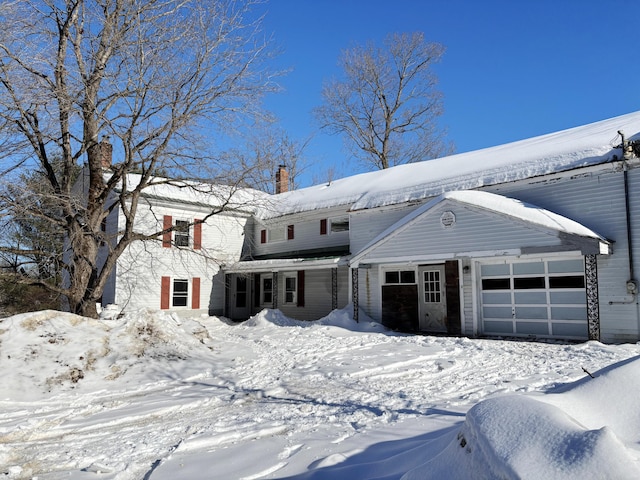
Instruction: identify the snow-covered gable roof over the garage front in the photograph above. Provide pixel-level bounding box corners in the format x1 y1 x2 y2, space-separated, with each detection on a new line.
350 190 610 265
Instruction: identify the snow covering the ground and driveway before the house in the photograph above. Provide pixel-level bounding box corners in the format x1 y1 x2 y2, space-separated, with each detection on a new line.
0 310 640 480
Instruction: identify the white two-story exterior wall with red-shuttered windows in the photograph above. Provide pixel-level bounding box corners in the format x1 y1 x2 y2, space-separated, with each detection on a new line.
114 200 247 313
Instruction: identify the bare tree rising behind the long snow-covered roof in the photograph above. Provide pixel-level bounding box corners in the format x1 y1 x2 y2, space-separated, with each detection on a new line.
315 33 452 169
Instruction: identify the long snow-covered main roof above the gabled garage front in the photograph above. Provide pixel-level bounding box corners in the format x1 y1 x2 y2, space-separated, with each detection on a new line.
260 112 640 218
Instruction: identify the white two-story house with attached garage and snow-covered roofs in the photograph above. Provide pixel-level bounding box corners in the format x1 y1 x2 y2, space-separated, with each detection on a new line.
97 112 640 342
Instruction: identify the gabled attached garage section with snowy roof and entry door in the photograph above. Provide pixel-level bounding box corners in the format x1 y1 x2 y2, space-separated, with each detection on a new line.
350 191 610 340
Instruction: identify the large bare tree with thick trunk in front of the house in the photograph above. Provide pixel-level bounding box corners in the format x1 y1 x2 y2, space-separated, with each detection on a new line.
0 0 275 316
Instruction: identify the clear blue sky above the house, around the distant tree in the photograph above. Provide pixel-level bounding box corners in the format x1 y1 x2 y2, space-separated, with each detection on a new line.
264 0 640 186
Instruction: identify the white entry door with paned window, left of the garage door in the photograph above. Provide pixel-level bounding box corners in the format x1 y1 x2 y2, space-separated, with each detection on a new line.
418 265 447 333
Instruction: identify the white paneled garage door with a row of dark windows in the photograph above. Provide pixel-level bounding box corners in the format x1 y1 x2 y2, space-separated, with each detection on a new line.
480 257 588 340
